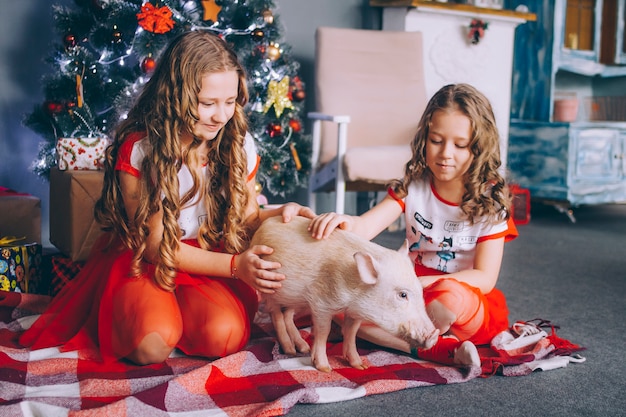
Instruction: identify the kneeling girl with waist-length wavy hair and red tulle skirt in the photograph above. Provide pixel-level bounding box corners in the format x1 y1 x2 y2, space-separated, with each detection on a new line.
20 31 314 365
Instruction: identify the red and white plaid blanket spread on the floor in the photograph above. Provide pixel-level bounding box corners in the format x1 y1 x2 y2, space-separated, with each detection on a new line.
0 292 584 417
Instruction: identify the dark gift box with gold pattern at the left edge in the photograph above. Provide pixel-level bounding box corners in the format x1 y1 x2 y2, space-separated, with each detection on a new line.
0 243 44 294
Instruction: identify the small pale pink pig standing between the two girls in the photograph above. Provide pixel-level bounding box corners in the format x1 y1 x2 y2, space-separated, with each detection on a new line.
251 217 439 372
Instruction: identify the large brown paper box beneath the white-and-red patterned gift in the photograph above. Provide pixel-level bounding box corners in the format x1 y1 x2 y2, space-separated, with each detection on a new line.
50 168 104 262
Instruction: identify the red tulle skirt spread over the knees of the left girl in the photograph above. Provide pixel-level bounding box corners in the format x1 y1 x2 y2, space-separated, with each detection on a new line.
20 234 258 362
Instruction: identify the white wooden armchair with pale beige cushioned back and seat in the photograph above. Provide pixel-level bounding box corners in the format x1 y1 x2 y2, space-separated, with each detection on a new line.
308 27 427 213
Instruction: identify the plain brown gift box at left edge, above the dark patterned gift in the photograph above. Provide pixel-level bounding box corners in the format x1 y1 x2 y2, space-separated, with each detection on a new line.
0 187 41 243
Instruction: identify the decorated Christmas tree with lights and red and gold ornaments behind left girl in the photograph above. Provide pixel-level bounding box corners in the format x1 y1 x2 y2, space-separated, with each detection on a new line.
24 0 310 197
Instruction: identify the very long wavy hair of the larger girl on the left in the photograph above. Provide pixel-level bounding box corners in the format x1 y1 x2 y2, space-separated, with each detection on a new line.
95 31 249 290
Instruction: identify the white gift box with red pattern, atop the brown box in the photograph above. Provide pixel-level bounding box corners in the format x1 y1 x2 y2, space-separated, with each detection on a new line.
56 137 111 171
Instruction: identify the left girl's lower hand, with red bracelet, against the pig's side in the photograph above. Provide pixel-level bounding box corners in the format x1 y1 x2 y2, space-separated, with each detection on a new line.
235 245 285 294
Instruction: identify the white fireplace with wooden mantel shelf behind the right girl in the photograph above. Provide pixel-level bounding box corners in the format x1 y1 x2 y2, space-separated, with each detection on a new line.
371 1 534 167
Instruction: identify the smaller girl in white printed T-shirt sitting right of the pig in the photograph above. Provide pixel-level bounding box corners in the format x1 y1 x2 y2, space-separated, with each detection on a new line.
310 84 517 366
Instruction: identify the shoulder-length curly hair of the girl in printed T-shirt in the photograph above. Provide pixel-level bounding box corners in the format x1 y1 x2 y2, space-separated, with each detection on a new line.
391 83 511 223
